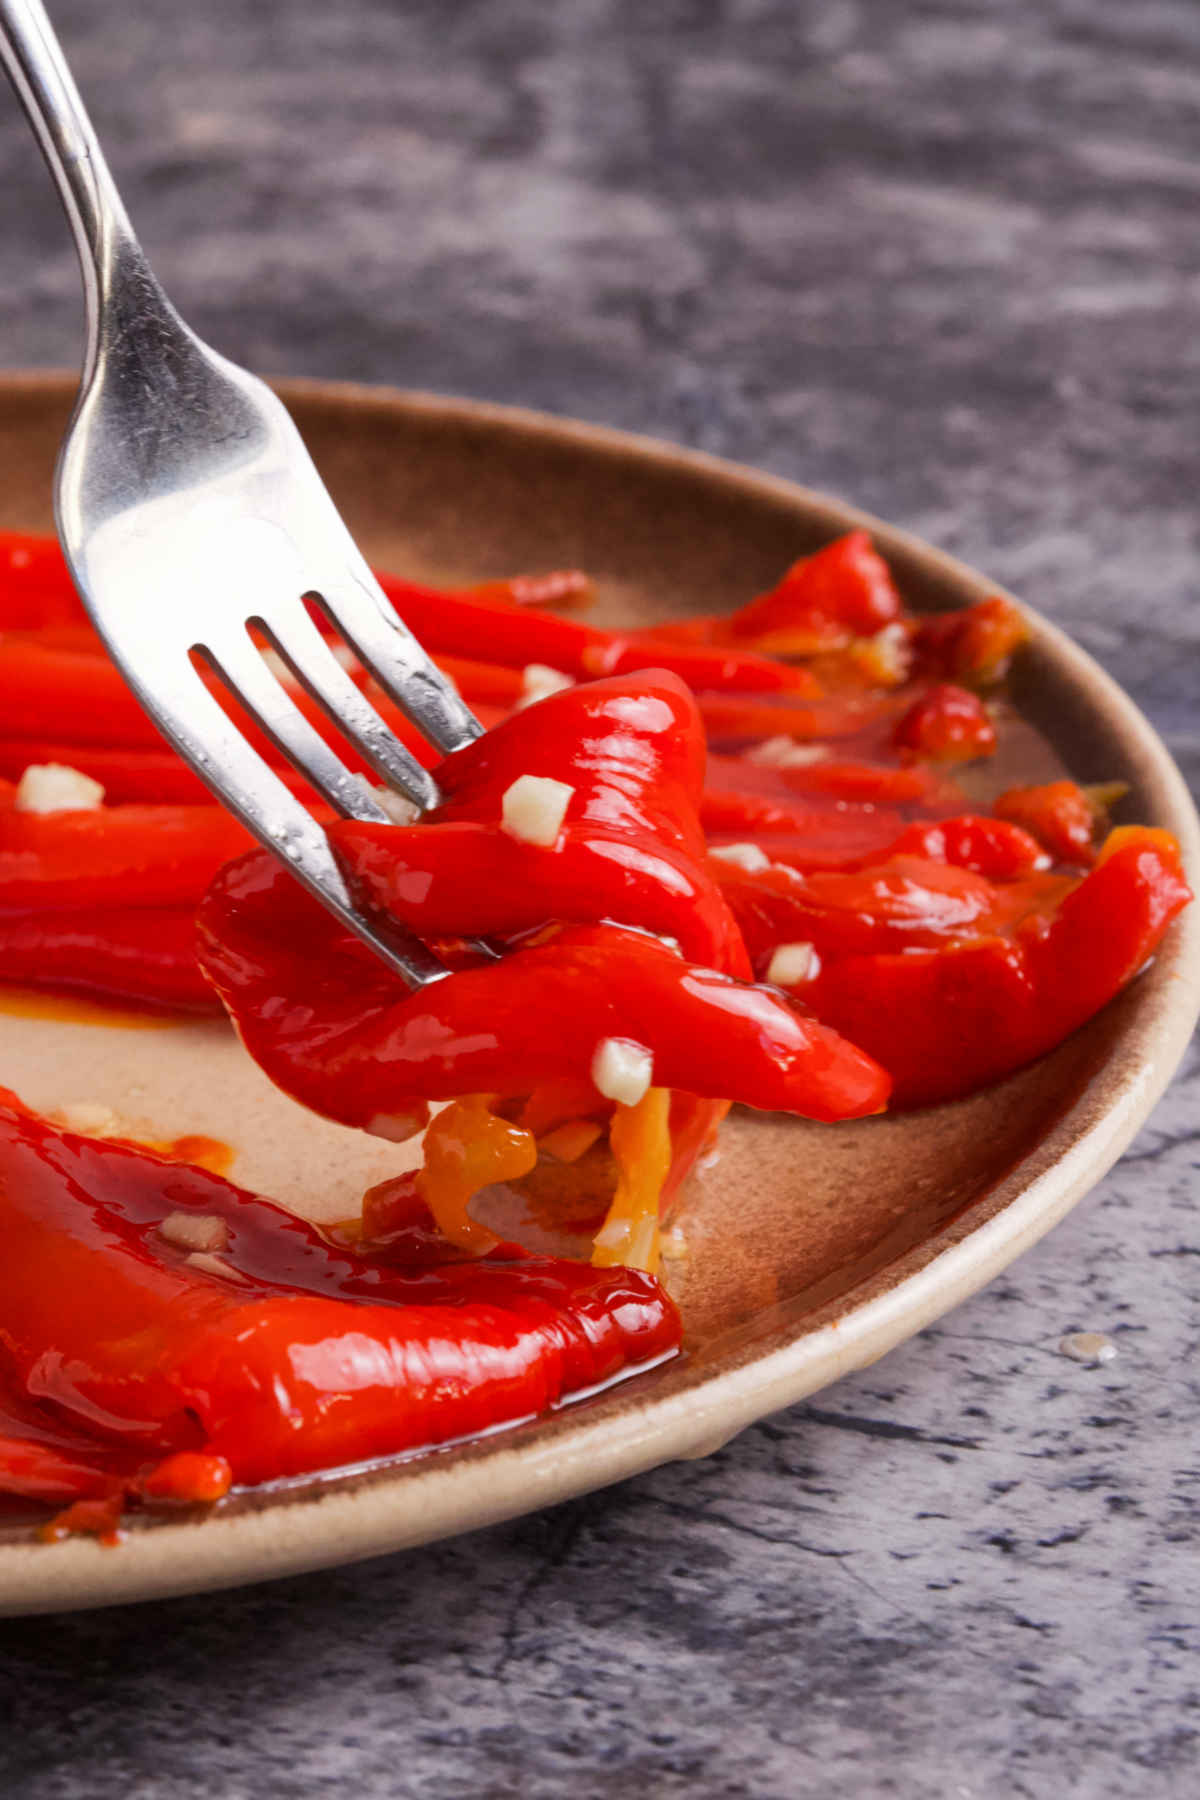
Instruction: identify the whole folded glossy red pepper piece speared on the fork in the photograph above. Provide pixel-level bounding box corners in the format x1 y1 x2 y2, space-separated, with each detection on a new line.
200 671 887 1125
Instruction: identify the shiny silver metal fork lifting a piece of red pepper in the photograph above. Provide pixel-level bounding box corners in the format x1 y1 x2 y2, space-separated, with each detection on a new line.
0 0 482 988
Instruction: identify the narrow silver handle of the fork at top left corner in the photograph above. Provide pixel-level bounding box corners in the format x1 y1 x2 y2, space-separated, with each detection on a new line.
0 0 159 385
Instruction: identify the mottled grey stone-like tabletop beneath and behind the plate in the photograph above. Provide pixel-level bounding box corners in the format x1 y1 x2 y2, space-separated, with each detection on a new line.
0 0 1200 1800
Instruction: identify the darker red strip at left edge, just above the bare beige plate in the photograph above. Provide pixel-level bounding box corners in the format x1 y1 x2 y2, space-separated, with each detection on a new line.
0 907 221 1013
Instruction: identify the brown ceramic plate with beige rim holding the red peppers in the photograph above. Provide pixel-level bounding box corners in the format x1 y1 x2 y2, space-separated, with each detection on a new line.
0 376 1200 1613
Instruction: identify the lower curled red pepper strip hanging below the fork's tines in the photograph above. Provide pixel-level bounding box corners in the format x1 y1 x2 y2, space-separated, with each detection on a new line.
198 853 887 1127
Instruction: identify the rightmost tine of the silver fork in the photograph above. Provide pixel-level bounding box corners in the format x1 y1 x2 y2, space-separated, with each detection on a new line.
309 561 484 756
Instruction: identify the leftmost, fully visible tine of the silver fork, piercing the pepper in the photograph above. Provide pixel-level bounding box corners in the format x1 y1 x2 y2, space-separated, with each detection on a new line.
135 646 448 988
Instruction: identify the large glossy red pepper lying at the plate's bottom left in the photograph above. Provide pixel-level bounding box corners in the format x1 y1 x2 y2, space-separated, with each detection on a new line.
0 1107 678 1498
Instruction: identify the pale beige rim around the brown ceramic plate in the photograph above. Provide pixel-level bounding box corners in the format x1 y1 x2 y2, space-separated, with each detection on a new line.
0 369 1200 1615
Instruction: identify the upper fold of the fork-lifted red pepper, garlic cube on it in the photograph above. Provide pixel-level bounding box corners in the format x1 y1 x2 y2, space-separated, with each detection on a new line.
329 670 748 976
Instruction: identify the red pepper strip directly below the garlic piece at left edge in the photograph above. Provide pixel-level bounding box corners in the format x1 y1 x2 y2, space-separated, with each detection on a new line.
0 783 250 909
